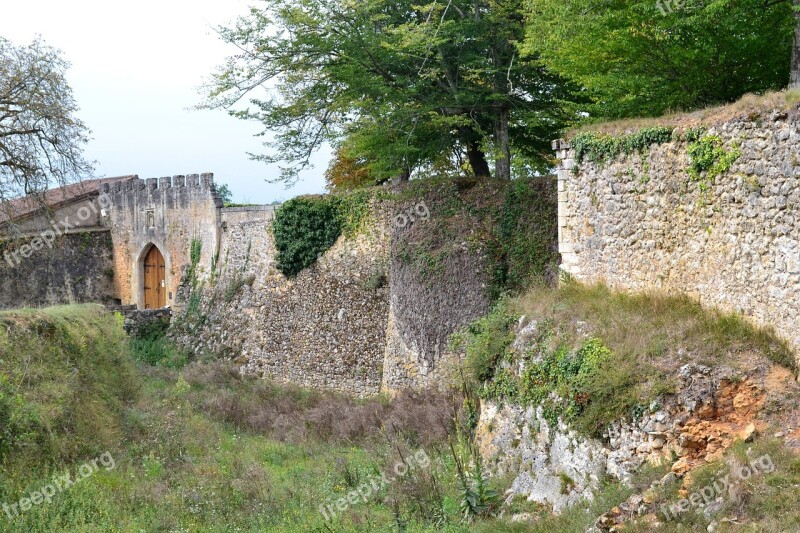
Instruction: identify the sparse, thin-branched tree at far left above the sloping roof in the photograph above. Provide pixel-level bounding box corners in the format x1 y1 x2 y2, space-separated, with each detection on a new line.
0 37 93 202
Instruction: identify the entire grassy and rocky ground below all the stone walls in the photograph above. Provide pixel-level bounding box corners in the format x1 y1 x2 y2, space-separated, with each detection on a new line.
0 284 800 532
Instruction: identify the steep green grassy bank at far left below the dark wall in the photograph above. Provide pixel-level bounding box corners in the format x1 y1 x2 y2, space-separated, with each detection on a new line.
0 305 138 468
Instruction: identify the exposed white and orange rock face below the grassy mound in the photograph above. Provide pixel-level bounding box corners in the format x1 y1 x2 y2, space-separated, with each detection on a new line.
476 364 765 513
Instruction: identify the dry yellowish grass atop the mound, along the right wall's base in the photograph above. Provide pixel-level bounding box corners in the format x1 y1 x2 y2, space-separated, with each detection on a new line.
511 282 796 372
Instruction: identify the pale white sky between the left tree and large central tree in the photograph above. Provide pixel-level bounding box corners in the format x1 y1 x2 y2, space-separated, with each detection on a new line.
0 0 329 203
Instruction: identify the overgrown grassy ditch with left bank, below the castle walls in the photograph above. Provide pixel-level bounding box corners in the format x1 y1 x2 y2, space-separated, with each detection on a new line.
0 306 512 532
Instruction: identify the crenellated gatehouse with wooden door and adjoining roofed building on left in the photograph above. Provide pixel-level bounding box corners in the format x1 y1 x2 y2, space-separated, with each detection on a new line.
0 173 272 309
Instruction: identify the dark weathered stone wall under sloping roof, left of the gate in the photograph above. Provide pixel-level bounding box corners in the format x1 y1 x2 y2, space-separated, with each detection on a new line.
0 230 115 309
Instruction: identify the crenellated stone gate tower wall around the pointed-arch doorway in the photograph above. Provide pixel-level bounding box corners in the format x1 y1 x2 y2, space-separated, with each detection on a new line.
100 174 222 308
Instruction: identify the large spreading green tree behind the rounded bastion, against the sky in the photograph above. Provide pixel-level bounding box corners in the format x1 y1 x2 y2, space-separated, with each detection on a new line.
204 0 569 183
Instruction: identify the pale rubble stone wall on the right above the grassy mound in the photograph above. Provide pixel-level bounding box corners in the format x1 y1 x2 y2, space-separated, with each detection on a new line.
554 111 800 354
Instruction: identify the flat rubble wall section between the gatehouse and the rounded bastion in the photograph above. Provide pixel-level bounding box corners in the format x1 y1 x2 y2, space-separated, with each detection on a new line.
171 200 389 395
